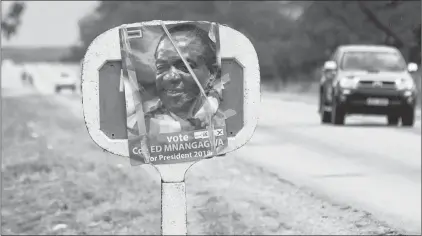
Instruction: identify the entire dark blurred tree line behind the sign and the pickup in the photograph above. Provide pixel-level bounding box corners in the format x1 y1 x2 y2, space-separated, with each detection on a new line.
4 0 421 83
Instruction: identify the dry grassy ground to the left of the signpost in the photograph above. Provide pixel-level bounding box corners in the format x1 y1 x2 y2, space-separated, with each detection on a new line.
2 97 160 234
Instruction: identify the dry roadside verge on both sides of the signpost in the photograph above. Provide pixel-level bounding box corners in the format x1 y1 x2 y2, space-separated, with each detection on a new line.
1 92 399 235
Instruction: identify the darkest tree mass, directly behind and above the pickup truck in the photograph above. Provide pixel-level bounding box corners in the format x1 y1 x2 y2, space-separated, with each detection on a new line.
286 0 421 81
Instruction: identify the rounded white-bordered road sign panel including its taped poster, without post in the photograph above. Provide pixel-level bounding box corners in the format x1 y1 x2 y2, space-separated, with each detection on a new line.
82 21 260 168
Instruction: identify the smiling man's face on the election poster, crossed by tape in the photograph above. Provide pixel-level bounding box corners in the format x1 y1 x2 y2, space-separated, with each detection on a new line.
156 32 212 110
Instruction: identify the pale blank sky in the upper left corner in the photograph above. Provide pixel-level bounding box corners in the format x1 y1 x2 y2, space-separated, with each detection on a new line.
1 1 98 47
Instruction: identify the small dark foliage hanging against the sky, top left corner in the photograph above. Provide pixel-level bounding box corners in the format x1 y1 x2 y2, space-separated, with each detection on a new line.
1 2 25 40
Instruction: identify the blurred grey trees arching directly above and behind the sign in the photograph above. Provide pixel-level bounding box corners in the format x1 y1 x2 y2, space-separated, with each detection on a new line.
62 1 302 68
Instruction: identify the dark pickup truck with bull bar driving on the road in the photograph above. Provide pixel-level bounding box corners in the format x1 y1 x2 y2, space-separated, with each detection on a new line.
319 45 418 126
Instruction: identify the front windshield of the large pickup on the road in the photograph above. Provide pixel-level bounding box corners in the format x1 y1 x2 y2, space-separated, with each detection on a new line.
341 52 406 72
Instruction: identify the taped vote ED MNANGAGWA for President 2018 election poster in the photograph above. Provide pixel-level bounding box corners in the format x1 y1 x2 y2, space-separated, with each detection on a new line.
119 22 228 164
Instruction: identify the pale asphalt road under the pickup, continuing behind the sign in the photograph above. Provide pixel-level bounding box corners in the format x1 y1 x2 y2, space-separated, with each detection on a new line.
2 68 421 234
